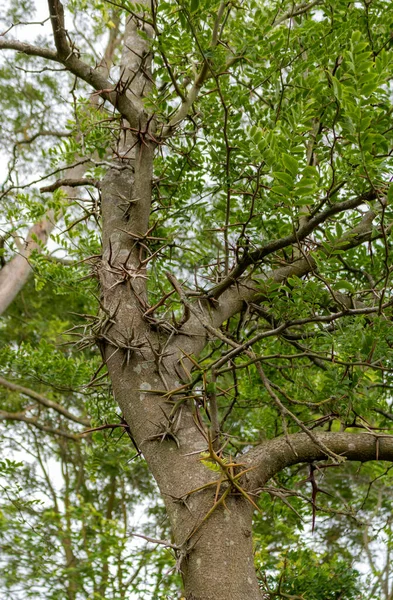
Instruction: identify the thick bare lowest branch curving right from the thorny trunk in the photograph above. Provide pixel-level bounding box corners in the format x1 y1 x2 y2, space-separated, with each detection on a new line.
240 432 393 489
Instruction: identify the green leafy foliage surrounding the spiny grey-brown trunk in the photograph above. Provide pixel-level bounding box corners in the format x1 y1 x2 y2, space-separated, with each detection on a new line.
0 0 393 600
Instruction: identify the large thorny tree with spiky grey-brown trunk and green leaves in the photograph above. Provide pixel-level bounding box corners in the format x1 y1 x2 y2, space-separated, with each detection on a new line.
0 0 393 600
